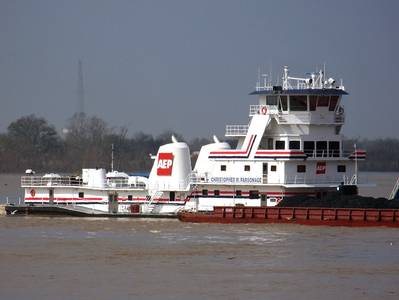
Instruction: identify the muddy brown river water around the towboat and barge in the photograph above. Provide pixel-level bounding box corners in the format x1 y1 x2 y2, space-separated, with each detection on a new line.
0 173 399 299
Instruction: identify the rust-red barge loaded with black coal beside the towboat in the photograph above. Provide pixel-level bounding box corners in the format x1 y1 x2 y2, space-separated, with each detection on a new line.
179 186 399 227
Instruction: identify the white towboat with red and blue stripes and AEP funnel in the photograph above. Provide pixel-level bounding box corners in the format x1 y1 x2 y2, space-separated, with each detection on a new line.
21 67 366 215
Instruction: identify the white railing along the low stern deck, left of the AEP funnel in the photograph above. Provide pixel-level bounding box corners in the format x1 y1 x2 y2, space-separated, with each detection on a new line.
21 176 146 189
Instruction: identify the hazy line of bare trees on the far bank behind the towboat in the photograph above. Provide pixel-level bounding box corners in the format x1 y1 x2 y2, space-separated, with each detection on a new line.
0 114 399 173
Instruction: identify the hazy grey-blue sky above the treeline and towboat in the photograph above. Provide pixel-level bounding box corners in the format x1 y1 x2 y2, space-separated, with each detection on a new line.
0 0 399 138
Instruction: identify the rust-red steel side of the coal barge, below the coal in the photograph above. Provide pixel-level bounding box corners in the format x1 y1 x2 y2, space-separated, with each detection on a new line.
179 207 399 227
